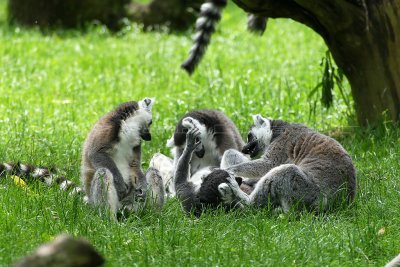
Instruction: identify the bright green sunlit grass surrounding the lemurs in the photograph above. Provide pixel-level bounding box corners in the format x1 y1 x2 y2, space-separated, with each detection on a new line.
0 0 400 266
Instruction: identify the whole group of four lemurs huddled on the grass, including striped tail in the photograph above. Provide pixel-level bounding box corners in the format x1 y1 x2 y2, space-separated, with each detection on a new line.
0 98 356 218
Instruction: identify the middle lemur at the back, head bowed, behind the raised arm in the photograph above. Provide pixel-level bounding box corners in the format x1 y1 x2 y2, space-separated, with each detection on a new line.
167 109 244 197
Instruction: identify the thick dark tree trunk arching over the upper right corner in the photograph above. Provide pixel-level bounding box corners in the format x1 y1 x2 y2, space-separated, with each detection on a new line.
234 0 400 125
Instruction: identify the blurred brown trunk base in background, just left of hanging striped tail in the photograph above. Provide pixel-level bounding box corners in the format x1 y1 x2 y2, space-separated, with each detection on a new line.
128 0 205 30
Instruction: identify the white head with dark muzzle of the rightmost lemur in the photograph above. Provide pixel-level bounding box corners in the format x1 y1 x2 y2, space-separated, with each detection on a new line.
242 114 272 158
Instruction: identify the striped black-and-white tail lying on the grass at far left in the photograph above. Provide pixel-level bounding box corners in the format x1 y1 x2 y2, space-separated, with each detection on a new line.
0 163 84 194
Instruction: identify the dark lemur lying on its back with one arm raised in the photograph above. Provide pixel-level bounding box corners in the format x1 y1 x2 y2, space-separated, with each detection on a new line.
174 127 241 216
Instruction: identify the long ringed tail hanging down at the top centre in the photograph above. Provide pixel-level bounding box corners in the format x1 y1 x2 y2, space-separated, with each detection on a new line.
181 0 227 74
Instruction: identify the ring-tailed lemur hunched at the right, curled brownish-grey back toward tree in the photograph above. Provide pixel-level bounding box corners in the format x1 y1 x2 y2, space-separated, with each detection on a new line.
219 115 356 212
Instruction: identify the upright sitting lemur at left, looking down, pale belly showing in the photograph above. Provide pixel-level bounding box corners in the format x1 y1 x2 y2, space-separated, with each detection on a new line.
81 98 164 217
